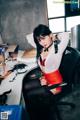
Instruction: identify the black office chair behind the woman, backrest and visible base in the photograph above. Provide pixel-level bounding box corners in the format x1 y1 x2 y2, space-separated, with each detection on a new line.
55 47 80 108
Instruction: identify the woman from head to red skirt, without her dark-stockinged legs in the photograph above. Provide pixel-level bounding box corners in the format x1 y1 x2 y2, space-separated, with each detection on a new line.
33 24 69 94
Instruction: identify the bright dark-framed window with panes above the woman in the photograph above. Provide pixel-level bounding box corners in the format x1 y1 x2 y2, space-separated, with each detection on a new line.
47 0 80 33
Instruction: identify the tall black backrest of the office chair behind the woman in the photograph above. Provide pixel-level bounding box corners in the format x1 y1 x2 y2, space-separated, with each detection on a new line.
59 47 80 90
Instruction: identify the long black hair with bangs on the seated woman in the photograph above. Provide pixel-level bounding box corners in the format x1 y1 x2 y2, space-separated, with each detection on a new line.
33 24 52 58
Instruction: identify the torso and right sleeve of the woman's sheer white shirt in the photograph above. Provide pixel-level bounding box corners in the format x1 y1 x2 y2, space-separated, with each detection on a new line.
38 32 69 73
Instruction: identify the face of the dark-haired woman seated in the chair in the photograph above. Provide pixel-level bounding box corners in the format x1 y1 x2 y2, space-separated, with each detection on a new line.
38 34 53 48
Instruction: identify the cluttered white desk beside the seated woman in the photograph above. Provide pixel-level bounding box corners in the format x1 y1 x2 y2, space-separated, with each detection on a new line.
0 59 37 105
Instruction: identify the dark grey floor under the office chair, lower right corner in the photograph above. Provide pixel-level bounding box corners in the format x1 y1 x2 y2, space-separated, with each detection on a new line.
59 85 80 120
